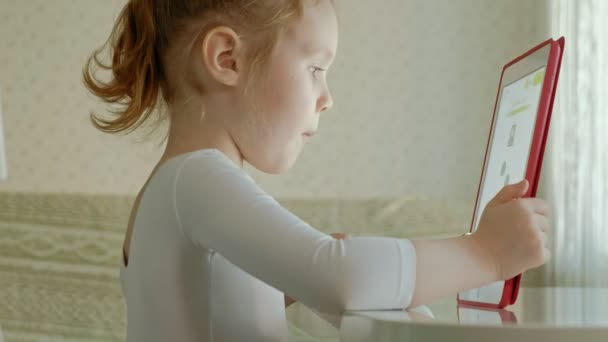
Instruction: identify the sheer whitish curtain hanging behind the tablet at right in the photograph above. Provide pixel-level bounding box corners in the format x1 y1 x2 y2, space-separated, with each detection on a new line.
544 0 608 287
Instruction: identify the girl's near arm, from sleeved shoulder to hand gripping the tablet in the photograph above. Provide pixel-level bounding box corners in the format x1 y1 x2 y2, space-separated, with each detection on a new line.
173 152 549 313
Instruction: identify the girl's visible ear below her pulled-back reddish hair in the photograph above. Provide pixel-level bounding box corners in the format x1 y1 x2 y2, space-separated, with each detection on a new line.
201 26 242 87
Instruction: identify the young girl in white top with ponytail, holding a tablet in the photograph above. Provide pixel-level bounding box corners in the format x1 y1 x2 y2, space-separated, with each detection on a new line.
84 0 549 341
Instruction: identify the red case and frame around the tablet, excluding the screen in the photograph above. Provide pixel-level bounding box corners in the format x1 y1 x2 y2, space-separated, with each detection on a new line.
457 37 565 308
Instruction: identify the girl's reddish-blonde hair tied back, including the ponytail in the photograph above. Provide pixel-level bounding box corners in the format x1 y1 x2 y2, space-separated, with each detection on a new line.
83 0 305 133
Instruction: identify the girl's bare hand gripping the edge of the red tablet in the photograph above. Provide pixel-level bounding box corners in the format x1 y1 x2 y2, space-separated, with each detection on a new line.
471 179 550 280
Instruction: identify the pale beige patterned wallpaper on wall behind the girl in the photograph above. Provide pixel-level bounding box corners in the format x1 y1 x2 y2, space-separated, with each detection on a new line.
0 0 546 201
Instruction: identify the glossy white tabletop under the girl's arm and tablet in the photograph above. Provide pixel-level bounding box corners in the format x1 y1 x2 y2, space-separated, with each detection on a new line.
290 288 608 342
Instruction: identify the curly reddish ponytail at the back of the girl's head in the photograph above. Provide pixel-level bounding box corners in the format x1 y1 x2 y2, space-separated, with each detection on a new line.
83 0 164 133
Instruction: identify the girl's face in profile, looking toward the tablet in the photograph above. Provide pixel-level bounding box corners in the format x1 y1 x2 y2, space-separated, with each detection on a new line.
232 0 338 173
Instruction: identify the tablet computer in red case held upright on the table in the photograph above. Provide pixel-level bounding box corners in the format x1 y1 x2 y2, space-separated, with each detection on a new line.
457 37 564 308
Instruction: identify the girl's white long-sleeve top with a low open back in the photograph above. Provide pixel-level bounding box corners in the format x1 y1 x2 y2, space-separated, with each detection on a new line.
120 149 416 342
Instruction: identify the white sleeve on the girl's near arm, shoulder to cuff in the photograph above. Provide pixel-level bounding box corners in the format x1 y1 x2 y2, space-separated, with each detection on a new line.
173 153 416 313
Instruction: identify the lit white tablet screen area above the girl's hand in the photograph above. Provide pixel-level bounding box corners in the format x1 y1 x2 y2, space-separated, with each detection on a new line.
473 66 545 230
